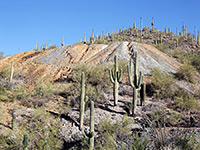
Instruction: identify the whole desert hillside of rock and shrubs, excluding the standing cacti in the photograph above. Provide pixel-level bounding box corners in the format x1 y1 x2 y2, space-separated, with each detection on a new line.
0 31 200 149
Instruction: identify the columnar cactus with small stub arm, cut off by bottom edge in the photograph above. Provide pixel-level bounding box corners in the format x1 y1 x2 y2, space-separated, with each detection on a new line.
89 101 94 150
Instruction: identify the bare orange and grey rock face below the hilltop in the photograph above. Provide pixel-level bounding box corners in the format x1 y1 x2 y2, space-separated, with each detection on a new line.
0 42 181 81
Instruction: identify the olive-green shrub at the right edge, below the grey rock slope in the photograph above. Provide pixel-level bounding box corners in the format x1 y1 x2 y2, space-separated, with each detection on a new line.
174 94 200 111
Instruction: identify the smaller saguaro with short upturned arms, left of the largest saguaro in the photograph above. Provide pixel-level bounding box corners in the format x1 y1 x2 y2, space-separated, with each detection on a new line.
109 55 122 106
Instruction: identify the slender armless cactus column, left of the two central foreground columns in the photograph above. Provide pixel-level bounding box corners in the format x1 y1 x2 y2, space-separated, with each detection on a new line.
79 72 85 129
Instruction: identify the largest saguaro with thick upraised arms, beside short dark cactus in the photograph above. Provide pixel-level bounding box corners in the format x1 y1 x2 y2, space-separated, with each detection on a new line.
127 52 145 115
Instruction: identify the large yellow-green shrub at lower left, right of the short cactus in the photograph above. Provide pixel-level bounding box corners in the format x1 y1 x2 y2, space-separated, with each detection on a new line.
19 107 63 150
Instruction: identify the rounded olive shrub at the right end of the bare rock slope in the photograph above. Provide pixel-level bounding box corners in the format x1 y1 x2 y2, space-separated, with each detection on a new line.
176 64 196 82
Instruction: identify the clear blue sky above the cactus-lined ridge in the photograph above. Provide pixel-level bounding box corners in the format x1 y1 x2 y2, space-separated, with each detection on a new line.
0 0 200 56
